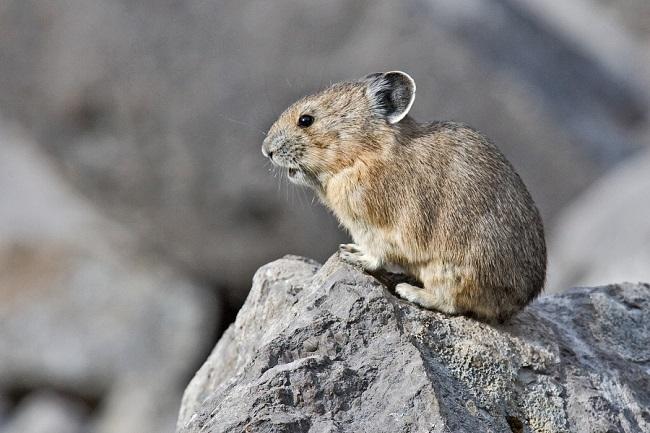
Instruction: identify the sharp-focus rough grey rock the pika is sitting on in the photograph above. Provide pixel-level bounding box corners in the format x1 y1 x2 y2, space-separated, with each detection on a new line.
177 256 650 433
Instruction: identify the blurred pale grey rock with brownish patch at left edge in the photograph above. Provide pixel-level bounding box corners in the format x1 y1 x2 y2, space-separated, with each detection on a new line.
0 122 220 433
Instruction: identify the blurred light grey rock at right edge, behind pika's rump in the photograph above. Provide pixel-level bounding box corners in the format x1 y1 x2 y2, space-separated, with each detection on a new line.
547 150 650 291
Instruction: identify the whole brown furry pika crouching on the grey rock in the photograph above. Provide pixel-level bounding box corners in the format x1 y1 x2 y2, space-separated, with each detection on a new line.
262 71 546 321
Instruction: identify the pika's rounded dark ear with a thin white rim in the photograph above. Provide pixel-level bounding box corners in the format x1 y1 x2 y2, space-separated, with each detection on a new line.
364 71 415 124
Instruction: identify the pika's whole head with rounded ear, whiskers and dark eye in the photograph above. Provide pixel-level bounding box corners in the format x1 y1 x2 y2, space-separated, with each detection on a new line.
262 71 415 188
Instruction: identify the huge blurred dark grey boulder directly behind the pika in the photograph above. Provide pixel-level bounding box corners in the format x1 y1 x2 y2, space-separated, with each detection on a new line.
0 0 648 305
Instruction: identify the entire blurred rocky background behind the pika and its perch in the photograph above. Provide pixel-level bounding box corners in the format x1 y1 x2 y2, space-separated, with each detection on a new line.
0 0 650 433
